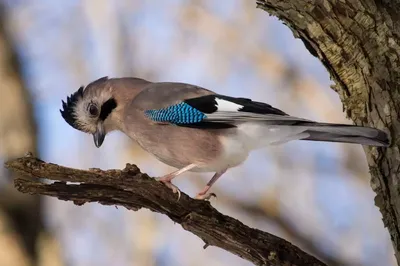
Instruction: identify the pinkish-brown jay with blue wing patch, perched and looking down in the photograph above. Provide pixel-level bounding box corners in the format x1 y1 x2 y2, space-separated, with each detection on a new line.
60 77 390 200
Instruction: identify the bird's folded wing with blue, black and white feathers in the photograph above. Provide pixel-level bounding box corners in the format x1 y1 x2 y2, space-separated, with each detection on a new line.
145 94 312 128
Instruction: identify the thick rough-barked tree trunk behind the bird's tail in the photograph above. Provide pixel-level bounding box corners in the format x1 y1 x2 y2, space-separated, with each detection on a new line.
257 0 400 264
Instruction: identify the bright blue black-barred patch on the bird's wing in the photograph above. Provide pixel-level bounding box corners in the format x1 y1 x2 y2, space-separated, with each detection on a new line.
144 102 207 124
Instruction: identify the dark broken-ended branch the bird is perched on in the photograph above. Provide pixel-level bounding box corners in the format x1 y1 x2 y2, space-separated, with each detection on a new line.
6 156 325 266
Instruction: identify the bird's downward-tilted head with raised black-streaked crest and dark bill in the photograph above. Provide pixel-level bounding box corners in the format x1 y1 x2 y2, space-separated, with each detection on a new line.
60 77 117 147
